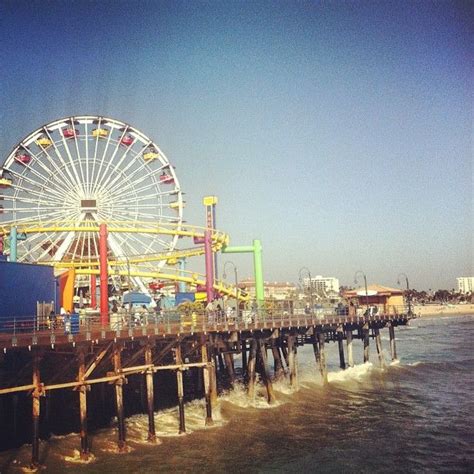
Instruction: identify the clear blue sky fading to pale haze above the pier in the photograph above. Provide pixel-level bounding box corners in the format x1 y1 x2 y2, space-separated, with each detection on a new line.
0 0 474 289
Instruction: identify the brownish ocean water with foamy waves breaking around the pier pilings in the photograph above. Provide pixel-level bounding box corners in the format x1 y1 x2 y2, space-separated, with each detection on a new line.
0 315 474 474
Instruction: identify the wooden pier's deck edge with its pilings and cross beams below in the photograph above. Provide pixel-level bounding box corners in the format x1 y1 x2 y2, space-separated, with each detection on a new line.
0 312 414 467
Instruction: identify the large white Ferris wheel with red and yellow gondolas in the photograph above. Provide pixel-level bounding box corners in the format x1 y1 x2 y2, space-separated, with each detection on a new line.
0 116 183 265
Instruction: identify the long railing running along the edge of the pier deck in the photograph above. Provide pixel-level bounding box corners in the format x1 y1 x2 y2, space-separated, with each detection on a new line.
0 306 415 347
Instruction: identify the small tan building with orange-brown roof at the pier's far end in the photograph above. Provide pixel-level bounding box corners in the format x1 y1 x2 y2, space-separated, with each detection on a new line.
343 285 405 314
